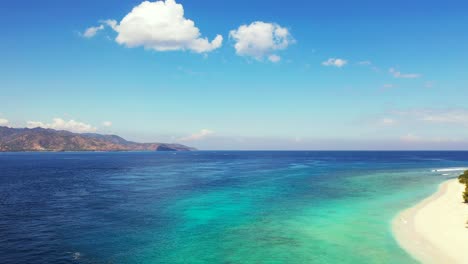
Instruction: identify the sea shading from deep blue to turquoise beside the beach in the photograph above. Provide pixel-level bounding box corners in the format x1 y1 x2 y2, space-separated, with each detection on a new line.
0 152 468 264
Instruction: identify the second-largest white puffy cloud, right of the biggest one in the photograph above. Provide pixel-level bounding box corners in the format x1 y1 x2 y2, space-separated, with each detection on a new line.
229 21 295 62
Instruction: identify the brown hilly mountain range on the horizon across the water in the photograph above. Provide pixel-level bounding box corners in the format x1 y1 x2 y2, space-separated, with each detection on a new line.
0 127 195 152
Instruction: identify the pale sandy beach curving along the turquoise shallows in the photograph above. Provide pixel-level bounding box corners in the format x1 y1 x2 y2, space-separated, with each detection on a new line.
393 179 468 264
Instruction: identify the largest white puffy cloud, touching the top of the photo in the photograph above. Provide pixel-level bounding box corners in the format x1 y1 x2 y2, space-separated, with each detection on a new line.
96 0 223 53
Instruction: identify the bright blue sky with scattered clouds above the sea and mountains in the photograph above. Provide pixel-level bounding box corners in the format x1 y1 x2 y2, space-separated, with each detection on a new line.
0 0 468 149
